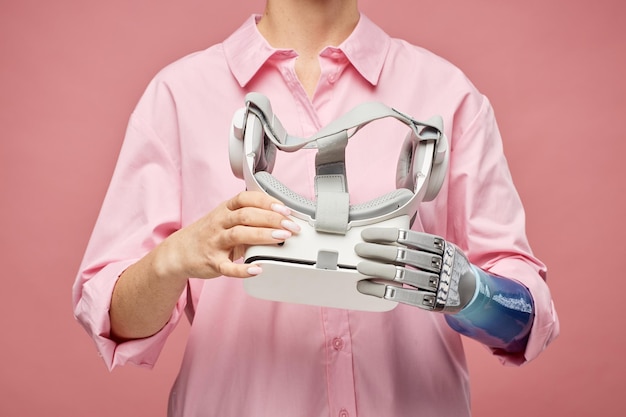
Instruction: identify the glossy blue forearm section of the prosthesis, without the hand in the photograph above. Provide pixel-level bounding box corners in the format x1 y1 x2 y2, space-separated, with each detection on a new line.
445 265 535 353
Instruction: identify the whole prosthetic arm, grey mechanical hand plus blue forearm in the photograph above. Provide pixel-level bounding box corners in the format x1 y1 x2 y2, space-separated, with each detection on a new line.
355 227 534 353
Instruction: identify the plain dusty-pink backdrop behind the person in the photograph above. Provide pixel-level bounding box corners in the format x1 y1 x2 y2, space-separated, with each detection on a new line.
0 0 626 417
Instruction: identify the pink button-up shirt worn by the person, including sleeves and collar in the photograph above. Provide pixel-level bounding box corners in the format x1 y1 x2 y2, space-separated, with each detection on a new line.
74 16 558 417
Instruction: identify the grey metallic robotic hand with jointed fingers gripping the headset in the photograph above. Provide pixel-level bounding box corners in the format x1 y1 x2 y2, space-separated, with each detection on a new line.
355 228 476 313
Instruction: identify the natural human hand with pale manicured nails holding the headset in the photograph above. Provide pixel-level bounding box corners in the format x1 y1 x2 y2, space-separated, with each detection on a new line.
150 191 300 278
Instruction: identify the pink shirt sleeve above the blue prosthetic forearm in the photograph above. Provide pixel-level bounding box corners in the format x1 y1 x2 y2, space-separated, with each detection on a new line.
435 95 559 365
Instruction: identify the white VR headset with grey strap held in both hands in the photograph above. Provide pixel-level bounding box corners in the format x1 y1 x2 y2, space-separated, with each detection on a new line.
229 93 448 311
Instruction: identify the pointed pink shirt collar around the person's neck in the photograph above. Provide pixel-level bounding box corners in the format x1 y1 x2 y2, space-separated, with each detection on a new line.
223 14 390 87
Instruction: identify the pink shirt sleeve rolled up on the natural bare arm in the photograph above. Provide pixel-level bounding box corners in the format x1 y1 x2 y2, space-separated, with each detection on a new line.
73 82 186 369
